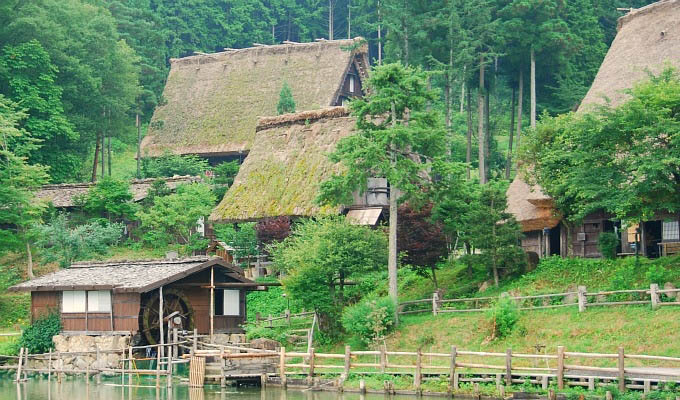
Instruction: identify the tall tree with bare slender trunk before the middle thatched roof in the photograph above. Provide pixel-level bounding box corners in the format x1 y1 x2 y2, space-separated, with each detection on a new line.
319 63 446 308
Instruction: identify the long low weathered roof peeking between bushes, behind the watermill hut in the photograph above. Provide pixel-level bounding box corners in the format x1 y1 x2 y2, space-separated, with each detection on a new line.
36 175 201 208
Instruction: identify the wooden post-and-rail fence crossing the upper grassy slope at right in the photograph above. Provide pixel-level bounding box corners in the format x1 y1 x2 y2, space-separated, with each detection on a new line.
398 284 680 315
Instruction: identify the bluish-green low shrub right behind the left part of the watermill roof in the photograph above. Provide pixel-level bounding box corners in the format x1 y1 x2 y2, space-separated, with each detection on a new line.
33 214 124 268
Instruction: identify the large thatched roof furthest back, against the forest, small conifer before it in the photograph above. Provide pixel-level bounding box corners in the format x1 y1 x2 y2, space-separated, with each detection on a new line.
142 38 368 156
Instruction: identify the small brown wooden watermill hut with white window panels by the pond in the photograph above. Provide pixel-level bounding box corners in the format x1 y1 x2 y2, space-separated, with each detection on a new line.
9 257 265 343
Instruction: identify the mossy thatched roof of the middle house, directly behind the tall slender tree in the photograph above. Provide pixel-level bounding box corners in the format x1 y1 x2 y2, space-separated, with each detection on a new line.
210 107 355 222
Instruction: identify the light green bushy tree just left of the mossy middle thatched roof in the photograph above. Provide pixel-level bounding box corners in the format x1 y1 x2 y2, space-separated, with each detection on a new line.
138 183 215 250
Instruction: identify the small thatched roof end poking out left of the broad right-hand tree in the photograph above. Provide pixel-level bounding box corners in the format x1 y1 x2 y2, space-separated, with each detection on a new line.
506 176 561 232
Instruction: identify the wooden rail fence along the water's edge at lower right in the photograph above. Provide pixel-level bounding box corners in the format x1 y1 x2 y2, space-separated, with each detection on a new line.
279 346 680 392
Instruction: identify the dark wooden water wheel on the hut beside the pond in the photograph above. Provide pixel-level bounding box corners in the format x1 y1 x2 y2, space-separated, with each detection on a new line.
139 289 194 344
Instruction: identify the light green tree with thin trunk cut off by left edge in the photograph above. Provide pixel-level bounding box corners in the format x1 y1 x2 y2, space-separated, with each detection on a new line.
0 95 48 278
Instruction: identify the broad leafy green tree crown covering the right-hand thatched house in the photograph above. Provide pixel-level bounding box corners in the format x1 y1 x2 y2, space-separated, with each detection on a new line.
522 68 680 234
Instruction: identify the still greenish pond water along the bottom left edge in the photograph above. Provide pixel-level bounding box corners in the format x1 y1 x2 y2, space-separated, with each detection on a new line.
0 376 398 400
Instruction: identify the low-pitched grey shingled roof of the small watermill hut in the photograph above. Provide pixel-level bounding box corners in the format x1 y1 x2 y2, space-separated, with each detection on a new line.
9 257 252 293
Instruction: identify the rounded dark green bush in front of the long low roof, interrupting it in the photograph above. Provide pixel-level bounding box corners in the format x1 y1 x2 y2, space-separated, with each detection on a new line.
77 177 137 221
